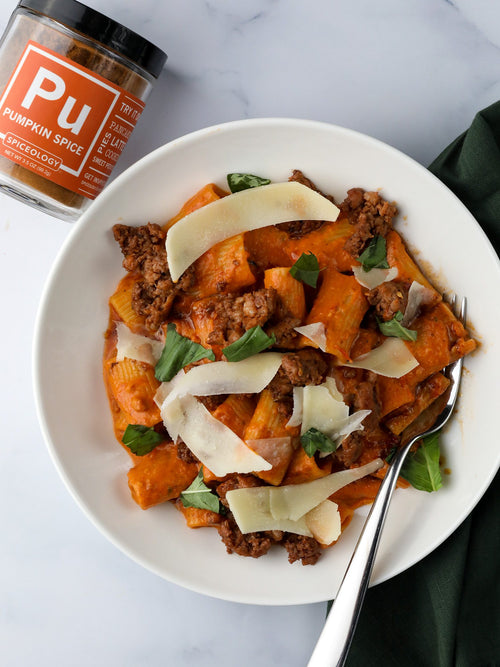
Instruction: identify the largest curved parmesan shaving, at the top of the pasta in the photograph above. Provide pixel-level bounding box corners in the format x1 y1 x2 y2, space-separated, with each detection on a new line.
166 182 339 282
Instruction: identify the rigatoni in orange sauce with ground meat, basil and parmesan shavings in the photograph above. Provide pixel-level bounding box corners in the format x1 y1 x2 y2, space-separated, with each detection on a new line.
103 170 476 565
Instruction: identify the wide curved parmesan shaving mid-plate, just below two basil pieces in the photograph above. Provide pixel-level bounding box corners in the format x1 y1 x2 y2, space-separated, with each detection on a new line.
159 352 283 408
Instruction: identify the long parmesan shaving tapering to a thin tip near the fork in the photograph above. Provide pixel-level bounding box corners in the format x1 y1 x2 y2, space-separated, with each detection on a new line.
270 459 384 521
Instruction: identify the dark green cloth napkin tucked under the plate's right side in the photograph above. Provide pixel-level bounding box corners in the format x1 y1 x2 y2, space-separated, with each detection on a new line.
338 102 500 667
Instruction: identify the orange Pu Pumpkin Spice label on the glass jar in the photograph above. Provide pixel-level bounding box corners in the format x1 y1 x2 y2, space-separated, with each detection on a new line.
0 41 145 199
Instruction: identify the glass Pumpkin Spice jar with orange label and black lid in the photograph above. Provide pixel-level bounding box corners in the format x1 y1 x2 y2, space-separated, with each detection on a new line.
0 0 167 220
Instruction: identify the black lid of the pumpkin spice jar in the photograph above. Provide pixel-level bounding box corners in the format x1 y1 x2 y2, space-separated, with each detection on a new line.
17 0 167 78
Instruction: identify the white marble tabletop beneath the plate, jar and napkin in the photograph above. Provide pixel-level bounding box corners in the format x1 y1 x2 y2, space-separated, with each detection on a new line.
0 0 500 667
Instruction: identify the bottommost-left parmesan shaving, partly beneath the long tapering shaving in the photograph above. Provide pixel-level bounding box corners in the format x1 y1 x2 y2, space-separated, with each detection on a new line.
226 486 312 537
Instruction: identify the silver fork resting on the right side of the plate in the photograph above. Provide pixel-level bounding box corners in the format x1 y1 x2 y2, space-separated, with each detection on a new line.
308 295 467 667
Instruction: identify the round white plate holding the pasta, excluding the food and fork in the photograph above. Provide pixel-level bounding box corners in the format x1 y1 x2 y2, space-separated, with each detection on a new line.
34 119 500 604
